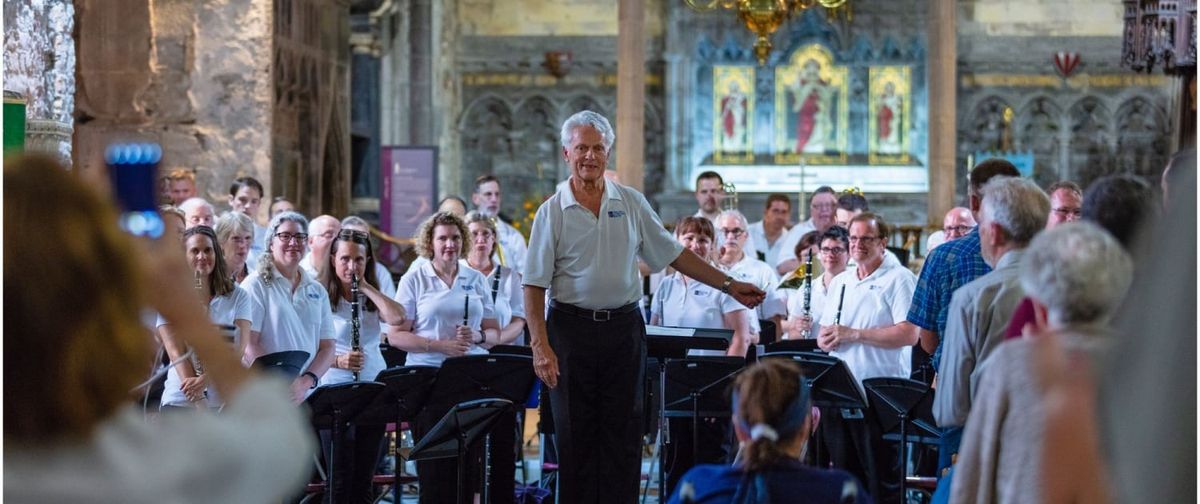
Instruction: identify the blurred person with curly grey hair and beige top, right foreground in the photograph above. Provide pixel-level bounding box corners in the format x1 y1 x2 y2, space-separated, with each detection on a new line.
950 223 1133 504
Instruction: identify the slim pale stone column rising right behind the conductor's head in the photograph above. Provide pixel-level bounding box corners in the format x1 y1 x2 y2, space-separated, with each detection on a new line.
617 0 646 191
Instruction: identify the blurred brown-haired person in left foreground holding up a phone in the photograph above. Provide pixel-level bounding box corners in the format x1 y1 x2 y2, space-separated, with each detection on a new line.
4 157 312 503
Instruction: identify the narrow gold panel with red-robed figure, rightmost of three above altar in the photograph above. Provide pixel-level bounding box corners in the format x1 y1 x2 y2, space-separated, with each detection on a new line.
866 66 912 163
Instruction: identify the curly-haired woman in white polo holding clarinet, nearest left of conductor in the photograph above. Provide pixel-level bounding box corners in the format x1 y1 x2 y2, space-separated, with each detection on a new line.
388 212 506 504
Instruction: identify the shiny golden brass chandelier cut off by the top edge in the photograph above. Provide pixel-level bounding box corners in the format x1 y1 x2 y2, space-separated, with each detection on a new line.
683 0 850 65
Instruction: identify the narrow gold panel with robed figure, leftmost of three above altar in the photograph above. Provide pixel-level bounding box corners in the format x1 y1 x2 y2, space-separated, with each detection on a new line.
713 66 754 163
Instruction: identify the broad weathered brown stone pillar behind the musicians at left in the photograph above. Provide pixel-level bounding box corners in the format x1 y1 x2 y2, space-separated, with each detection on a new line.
76 0 272 220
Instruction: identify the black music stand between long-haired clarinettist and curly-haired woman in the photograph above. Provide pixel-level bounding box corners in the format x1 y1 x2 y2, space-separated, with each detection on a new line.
354 366 438 503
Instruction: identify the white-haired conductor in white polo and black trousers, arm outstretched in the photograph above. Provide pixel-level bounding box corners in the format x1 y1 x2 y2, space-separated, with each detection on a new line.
523 110 764 503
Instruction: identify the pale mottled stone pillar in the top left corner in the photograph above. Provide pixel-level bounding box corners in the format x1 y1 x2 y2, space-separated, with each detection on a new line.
4 0 76 164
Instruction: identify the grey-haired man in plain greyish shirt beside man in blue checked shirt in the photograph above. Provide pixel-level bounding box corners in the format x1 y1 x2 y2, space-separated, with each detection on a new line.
934 176 1050 436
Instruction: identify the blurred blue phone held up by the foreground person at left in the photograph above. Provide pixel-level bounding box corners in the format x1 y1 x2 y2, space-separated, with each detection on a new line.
104 144 164 238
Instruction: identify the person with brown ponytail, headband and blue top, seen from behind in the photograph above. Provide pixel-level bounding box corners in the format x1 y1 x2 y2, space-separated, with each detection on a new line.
671 359 872 504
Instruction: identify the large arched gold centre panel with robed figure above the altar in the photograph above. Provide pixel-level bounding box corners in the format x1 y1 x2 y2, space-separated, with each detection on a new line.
775 44 850 164
